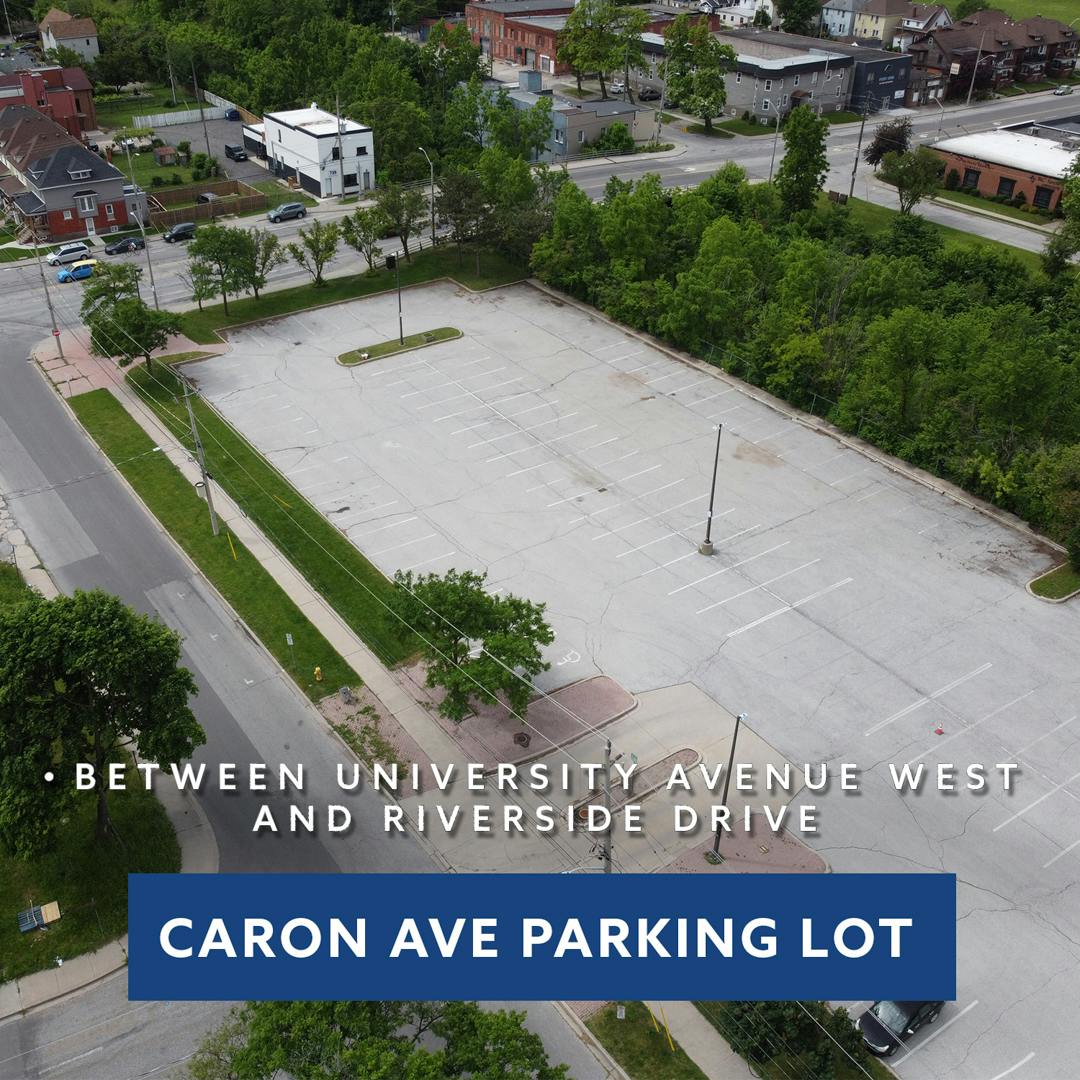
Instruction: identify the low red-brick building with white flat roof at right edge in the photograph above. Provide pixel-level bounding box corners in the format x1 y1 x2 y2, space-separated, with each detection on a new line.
931 131 1080 211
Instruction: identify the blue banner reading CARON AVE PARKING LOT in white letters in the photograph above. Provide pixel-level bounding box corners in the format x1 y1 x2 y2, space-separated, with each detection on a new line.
127 874 956 1001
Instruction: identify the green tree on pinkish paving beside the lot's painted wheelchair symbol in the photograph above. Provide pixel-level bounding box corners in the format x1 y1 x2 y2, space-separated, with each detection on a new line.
391 570 555 721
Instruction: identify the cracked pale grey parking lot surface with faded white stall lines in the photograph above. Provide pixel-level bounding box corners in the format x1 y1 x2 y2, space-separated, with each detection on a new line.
188 284 1080 1080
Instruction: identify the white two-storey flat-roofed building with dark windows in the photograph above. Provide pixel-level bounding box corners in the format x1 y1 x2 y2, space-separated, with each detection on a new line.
260 103 375 197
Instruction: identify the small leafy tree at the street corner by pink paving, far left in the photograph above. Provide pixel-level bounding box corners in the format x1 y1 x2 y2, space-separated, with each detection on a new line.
79 262 181 367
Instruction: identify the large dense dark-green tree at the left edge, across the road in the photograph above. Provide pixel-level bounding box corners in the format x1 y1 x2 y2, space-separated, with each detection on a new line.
0 590 205 856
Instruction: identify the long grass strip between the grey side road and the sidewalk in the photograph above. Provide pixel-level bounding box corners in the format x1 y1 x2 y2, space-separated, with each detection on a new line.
68 388 360 691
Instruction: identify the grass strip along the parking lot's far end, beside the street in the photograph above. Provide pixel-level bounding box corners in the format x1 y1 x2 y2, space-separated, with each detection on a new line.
184 247 528 345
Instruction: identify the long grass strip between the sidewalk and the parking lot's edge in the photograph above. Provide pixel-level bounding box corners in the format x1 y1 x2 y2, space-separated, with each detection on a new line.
120 361 415 665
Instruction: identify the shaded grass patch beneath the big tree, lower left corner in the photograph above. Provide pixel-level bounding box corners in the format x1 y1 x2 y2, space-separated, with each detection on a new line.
0 768 180 983
